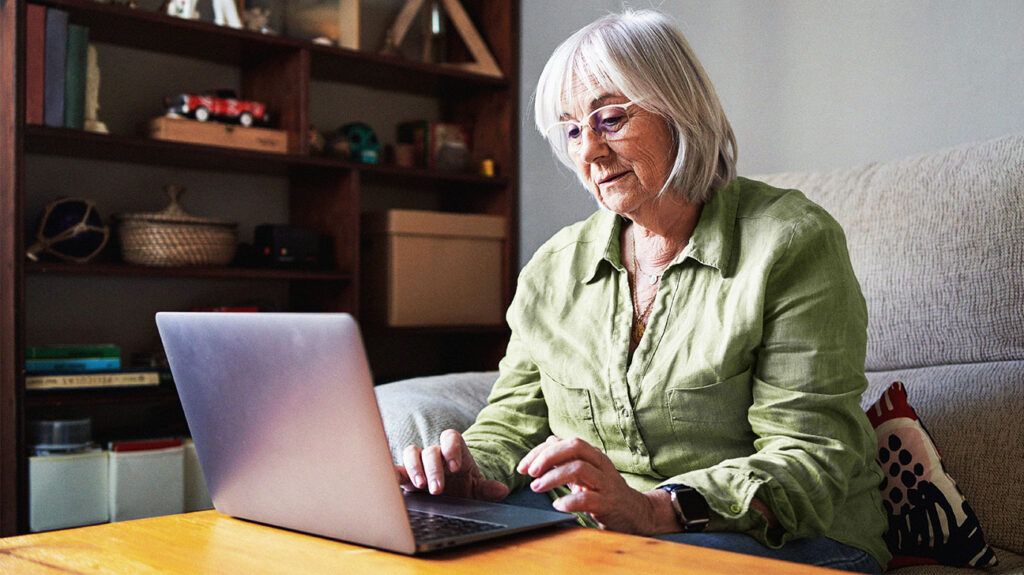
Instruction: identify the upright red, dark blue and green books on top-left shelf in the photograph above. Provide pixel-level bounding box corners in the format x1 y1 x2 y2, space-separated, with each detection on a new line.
25 4 89 130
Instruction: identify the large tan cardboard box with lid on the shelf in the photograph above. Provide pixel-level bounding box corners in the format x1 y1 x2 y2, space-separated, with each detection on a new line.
362 210 507 327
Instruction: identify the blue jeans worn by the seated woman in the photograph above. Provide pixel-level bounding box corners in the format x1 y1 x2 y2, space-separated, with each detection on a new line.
503 489 882 573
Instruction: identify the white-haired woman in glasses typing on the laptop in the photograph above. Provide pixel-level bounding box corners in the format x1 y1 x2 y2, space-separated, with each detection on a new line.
399 11 889 572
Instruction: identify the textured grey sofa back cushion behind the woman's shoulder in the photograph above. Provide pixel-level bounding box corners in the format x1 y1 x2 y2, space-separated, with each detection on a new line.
759 134 1024 370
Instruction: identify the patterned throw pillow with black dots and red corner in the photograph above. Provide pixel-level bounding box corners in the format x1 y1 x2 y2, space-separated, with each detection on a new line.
867 382 997 569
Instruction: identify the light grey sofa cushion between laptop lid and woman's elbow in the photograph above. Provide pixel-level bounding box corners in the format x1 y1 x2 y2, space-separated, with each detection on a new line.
375 371 498 463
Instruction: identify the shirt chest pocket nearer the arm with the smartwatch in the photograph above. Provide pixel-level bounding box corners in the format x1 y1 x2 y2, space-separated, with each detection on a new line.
666 369 754 447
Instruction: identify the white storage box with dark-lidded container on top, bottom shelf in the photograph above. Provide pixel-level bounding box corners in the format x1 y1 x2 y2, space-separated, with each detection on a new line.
29 449 110 531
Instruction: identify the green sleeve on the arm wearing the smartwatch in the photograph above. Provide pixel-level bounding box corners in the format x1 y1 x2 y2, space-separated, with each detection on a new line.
664 210 874 547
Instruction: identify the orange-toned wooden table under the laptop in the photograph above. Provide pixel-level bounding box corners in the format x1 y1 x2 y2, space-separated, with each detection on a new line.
0 511 836 575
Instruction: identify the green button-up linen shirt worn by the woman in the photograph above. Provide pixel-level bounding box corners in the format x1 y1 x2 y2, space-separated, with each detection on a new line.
465 178 890 566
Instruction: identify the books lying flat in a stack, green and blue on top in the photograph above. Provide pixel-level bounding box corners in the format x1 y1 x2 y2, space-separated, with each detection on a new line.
25 344 170 390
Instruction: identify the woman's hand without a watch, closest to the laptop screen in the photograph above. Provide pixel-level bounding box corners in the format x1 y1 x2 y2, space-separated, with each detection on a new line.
394 430 509 501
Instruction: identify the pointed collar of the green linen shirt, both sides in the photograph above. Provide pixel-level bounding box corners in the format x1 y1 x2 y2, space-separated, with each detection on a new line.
581 178 739 283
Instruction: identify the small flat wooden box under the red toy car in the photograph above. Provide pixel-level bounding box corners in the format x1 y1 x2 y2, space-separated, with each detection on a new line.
145 116 288 153
